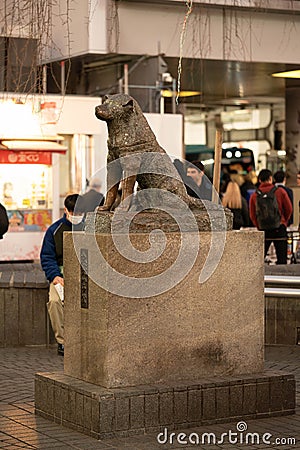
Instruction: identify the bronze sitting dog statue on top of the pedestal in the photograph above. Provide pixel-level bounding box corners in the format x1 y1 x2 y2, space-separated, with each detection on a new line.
95 94 210 211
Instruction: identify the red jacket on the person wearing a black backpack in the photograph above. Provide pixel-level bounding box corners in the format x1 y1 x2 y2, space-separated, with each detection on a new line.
249 182 293 228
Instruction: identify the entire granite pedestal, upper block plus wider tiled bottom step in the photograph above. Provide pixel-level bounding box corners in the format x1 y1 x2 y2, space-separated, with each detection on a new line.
35 224 295 438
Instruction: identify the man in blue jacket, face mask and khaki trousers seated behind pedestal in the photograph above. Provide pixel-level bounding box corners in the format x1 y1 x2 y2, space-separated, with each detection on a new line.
40 194 83 355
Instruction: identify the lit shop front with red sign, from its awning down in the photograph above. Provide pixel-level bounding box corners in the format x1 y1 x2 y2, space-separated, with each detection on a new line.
0 139 67 260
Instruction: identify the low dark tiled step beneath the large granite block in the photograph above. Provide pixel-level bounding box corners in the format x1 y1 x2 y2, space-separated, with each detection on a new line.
35 371 295 439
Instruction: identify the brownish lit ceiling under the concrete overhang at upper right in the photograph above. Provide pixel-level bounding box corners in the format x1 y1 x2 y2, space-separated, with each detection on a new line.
165 58 300 108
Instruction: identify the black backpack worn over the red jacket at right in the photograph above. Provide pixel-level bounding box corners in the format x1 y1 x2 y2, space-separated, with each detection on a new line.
256 186 281 230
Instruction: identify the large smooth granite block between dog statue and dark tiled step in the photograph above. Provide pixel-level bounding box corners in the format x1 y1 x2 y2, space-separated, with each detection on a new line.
64 231 264 388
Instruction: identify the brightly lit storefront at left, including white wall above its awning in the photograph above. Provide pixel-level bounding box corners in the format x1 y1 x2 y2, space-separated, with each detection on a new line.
0 98 67 261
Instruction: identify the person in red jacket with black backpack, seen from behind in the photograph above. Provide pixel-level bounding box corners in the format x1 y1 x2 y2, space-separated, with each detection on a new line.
249 169 293 264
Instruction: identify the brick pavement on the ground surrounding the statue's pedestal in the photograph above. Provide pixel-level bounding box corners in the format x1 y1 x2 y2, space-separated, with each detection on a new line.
0 346 300 450
